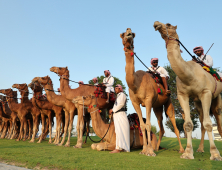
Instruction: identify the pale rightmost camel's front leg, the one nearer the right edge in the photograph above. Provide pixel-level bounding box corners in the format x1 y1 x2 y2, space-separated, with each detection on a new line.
200 90 222 161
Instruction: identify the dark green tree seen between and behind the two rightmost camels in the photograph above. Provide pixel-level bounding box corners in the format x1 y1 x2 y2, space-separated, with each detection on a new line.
164 65 199 136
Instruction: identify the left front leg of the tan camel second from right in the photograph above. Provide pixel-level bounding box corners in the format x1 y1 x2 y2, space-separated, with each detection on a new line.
132 101 152 156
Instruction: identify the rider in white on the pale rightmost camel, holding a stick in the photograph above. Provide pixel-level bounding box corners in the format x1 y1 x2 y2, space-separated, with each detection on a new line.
193 46 222 77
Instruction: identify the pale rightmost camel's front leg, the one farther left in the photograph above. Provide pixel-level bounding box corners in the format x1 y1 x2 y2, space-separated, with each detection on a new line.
177 92 194 159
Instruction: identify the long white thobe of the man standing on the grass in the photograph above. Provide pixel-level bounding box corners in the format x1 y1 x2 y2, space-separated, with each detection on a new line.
113 92 130 152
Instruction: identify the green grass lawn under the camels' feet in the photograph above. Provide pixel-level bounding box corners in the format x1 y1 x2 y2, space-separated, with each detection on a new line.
0 137 222 170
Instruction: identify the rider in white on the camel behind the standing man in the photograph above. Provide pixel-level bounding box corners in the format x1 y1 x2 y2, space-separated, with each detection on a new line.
103 70 114 103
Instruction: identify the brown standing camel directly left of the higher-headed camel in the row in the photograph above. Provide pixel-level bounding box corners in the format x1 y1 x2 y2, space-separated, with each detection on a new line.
32 76 67 146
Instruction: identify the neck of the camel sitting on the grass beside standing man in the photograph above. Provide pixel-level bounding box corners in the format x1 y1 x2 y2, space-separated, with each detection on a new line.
90 108 110 142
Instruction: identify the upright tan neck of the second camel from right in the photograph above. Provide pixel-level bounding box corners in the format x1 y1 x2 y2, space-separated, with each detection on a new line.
125 51 137 92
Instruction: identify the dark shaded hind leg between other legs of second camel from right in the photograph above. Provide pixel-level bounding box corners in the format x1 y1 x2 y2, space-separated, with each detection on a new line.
153 107 165 151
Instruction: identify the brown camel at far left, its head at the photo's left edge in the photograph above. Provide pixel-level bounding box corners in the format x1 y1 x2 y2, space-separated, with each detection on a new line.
0 89 20 139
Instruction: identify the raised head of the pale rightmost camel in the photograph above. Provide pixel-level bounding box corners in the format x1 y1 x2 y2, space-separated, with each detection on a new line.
153 21 179 41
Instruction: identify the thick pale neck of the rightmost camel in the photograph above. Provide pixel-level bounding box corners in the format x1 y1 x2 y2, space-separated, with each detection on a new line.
167 41 193 85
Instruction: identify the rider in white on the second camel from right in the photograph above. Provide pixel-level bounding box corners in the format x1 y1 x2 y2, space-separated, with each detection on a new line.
148 58 170 95
